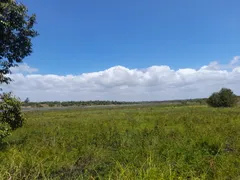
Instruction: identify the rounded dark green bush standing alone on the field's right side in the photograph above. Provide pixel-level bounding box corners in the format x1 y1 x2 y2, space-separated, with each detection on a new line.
207 88 237 107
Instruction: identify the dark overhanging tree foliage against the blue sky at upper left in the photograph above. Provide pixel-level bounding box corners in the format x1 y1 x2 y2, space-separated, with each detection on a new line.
0 0 38 84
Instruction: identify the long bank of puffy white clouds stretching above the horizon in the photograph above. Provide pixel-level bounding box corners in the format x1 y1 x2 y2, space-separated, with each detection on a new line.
1 56 240 101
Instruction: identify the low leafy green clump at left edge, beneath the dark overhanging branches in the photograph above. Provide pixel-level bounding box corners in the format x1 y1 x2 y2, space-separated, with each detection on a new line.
0 93 24 142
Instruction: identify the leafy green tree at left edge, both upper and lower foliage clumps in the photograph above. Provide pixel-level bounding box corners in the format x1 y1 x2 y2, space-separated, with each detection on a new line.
0 0 38 141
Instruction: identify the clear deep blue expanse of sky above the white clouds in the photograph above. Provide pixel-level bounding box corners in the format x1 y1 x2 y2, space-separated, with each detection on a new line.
21 0 240 75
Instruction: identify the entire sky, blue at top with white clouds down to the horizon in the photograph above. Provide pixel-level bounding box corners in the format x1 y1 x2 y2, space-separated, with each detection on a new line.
4 0 240 101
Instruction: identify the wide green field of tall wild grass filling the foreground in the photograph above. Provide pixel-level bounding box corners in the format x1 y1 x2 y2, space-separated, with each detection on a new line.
0 106 240 180
